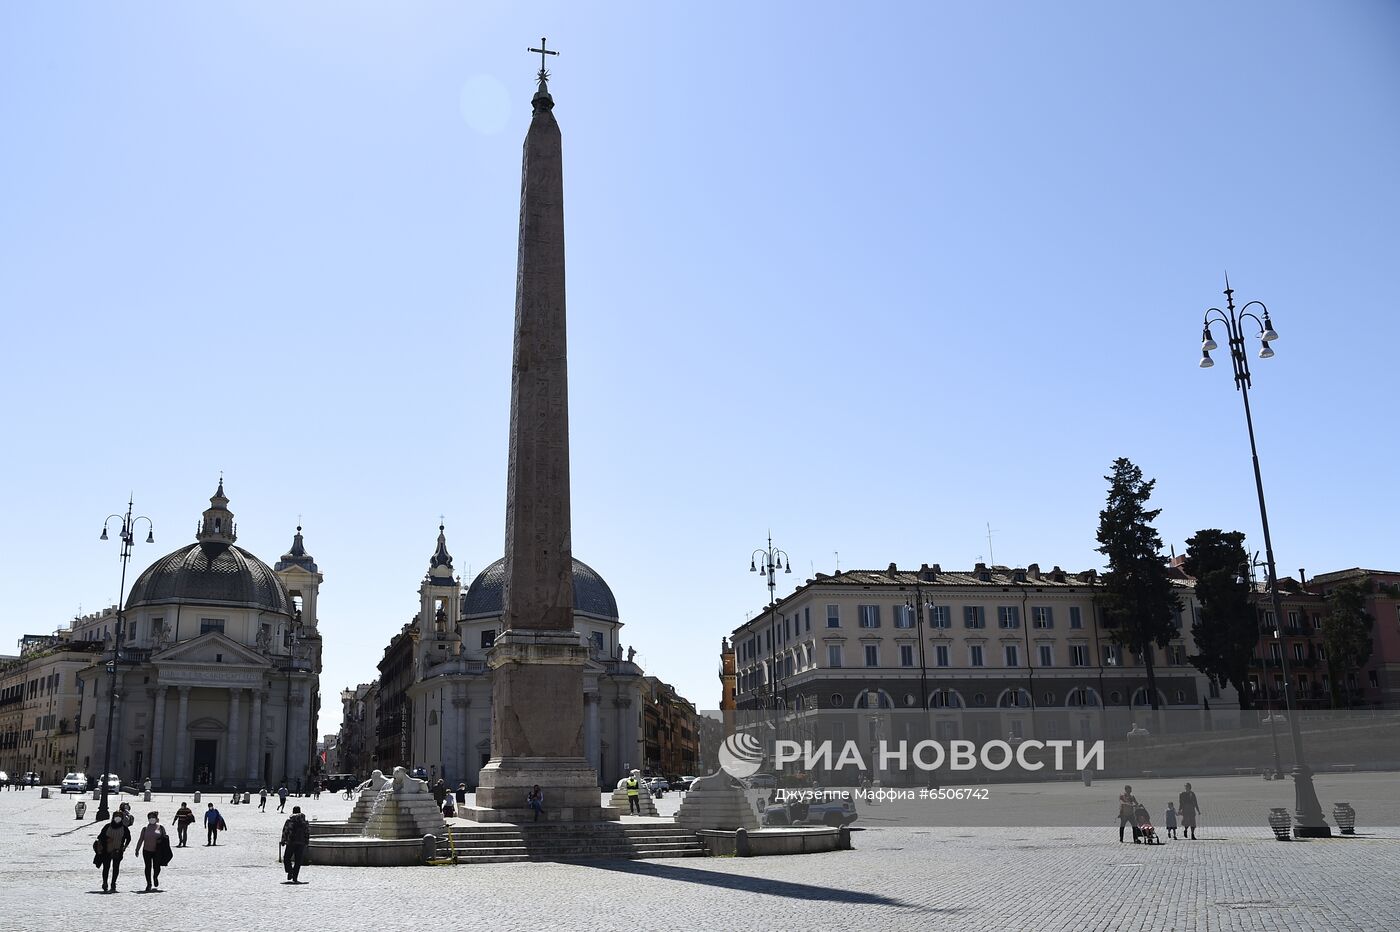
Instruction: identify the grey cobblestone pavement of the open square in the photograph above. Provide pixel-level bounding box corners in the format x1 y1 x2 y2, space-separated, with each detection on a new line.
0 775 1400 932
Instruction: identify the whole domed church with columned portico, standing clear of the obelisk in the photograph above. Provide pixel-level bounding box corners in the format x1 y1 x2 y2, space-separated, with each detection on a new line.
73 479 322 789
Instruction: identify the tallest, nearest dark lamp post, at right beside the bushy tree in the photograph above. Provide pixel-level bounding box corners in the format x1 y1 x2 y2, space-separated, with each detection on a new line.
1200 276 1331 838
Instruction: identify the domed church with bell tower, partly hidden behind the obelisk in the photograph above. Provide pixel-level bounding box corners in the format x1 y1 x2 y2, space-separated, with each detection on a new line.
372 526 644 788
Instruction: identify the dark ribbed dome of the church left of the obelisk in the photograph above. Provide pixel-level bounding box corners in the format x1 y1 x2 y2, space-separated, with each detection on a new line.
126 543 293 614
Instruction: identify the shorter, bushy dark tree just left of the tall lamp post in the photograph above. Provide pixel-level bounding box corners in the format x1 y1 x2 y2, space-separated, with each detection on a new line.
1183 528 1259 708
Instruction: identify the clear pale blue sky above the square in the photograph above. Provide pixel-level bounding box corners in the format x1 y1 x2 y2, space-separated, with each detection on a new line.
0 0 1400 728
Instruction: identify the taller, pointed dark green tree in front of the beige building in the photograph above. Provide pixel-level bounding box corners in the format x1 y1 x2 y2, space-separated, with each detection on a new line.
1099 456 1182 709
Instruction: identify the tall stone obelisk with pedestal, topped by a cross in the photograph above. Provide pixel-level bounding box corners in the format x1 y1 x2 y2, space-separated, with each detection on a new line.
472 41 616 821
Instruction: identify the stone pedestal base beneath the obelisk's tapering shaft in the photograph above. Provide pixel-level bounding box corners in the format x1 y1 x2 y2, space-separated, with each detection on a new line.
458 628 622 821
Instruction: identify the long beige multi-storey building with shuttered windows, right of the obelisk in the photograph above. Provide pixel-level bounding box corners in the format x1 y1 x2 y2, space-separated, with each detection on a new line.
729 564 1239 739
